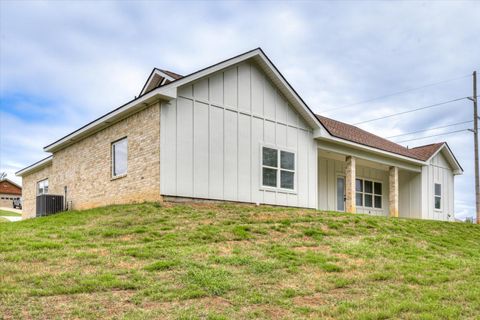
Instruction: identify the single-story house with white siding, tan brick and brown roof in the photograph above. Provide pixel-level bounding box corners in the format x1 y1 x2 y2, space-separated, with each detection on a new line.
17 48 462 220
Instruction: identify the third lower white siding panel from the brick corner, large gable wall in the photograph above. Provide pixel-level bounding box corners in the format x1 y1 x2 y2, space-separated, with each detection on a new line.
193 102 209 198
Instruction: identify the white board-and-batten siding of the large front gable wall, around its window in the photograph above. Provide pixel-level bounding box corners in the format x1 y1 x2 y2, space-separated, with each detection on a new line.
160 61 317 208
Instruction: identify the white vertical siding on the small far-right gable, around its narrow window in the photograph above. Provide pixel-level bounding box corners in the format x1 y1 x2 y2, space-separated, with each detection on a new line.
422 152 454 221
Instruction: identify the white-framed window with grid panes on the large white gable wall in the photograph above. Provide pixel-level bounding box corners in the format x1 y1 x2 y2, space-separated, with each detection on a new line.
262 147 295 190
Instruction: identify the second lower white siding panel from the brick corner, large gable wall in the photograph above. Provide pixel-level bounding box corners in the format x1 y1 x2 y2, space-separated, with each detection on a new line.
177 98 193 197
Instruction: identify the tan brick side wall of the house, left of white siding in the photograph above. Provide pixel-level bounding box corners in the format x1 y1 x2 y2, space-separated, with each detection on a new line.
23 104 161 218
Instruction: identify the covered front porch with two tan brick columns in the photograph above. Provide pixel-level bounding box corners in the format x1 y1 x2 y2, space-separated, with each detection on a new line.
318 144 422 218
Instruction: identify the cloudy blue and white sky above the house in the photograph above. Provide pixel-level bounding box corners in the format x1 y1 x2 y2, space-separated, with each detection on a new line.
0 0 480 218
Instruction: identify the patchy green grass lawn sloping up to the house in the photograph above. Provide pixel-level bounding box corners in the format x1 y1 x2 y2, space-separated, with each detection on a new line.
0 203 480 319
